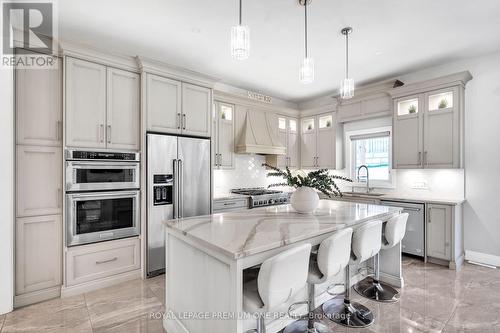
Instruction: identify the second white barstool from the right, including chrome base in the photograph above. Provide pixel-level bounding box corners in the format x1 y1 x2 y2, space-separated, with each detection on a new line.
323 220 382 327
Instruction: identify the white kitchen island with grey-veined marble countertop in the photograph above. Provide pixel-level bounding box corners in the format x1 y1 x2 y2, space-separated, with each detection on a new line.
163 200 403 333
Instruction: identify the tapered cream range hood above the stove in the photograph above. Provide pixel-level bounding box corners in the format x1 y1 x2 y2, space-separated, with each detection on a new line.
236 109 286 155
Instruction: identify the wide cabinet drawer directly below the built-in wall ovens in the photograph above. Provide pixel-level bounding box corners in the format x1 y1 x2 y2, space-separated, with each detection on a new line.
66 238 140 286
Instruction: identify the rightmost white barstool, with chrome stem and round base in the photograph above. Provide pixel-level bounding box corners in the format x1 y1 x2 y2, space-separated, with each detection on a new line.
354 213 409 302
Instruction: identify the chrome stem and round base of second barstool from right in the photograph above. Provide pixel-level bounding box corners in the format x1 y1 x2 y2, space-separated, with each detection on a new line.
323 266 374 327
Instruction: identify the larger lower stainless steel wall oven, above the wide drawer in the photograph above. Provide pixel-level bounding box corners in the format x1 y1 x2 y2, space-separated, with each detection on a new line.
66 190 140 246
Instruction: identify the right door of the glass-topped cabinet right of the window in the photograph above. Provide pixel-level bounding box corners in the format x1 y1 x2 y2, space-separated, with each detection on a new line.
423 88 460 169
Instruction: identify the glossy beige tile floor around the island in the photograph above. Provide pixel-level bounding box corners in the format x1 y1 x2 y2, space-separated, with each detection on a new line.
0 258 500 333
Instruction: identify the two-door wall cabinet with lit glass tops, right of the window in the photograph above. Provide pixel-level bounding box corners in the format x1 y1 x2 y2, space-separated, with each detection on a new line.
393 86 463 169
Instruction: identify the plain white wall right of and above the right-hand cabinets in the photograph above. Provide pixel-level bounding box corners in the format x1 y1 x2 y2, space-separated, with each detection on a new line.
400 52 500 262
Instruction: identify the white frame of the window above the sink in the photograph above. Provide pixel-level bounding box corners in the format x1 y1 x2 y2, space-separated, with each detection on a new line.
345 126 395 188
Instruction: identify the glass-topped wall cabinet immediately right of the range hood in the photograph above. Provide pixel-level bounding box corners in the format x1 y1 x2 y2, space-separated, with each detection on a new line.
266 115 300 169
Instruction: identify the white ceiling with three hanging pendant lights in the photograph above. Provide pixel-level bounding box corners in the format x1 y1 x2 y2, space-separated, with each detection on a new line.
58 0 500 102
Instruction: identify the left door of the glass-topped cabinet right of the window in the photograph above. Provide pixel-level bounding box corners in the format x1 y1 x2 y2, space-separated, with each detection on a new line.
393 96 423 169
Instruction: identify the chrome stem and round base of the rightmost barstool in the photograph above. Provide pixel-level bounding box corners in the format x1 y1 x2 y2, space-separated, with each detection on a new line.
354 253 399 303
